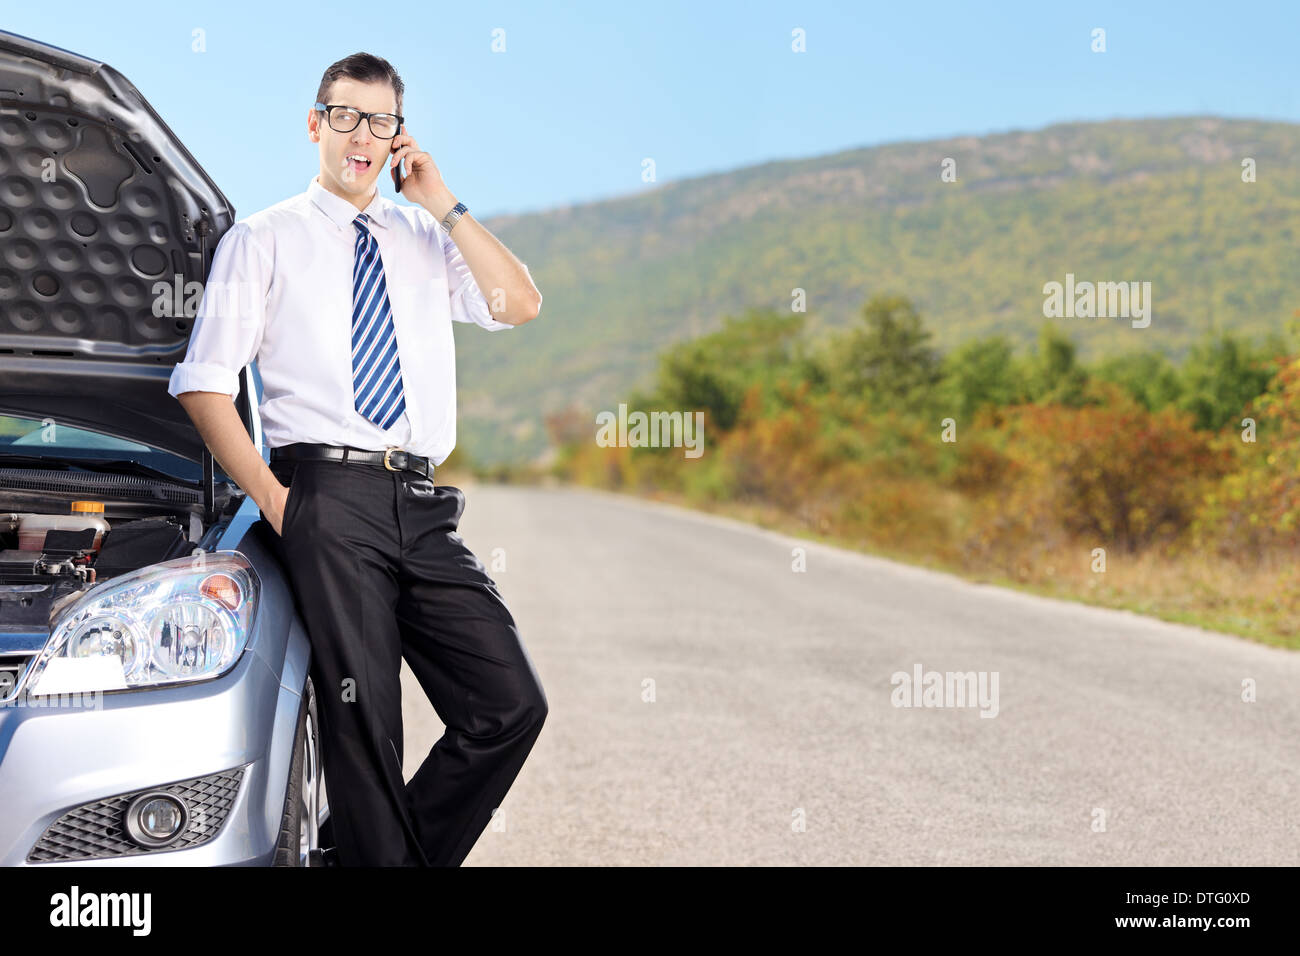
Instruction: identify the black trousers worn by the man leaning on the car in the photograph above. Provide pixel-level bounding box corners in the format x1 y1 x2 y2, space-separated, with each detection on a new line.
263 460 547 866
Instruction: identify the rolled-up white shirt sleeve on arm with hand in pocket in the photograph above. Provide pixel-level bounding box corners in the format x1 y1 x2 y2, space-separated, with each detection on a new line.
168 222 270 402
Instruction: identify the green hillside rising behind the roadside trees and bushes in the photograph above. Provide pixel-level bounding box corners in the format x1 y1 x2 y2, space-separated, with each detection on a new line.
456 117 1300 463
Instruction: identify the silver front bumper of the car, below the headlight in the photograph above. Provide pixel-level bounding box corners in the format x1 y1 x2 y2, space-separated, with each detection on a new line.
0 634 302 866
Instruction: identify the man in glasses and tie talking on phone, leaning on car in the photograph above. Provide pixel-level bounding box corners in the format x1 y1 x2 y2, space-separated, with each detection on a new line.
169 53 547 866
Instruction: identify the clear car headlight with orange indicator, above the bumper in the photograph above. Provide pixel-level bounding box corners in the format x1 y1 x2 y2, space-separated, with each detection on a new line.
29 551 261 696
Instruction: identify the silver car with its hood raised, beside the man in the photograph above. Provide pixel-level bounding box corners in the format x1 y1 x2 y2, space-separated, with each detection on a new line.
0 31 332 866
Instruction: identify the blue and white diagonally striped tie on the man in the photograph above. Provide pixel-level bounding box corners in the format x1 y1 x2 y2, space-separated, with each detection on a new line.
352 212 406 429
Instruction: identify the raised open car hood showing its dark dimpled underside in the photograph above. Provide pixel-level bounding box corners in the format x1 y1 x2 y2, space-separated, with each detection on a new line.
0 31 254 462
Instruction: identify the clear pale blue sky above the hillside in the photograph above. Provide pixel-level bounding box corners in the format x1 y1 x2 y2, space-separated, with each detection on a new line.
0 0 1300 217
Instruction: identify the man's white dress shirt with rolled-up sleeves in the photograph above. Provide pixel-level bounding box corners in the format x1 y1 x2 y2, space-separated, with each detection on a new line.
168 178 514 464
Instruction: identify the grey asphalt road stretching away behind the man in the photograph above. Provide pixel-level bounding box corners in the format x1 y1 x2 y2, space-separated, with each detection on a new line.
390 483 1300 865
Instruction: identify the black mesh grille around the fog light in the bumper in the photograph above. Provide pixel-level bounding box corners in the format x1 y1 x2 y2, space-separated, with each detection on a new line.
27 765 247 864
